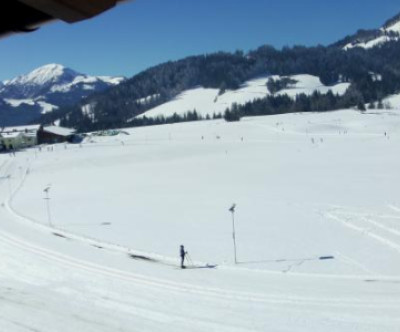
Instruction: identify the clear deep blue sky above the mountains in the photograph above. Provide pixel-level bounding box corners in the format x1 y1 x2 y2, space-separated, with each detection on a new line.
0 0 400 80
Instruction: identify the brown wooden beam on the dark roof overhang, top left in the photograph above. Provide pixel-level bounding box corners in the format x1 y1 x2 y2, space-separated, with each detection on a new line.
18 0 119 23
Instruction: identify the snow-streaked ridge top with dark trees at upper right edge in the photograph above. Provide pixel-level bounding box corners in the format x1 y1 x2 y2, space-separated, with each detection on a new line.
342 14 400 50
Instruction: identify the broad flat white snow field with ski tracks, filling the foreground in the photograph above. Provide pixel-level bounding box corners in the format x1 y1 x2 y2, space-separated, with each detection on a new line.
0 110 400 332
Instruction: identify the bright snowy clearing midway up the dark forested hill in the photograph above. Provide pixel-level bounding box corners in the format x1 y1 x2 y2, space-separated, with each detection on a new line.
140 75 350 117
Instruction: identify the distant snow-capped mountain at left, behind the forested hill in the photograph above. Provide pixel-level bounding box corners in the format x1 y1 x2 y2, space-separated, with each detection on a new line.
0 64 125 125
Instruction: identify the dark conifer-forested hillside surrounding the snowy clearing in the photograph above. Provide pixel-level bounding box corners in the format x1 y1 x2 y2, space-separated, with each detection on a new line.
42 13 400 131
